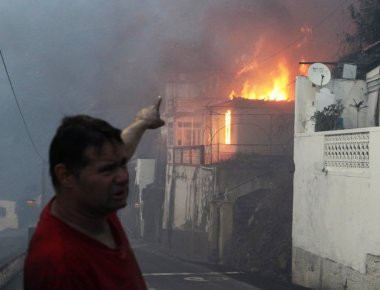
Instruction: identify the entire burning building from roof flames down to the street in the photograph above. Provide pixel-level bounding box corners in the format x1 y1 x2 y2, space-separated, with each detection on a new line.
131 15 320 277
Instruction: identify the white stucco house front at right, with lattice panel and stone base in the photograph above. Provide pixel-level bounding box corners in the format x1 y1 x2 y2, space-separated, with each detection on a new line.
292 67 380 289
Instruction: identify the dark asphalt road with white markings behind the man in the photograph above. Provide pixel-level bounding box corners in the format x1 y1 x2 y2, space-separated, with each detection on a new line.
1 241 304 290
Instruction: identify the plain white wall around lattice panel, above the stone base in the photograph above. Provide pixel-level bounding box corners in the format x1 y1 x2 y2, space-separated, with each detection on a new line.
293 127 380 273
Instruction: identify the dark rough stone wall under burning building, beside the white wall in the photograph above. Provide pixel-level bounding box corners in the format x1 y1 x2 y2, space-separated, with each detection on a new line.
225 158 293 281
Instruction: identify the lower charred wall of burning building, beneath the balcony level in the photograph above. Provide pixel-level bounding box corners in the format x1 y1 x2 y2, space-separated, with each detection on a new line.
154 154 294 280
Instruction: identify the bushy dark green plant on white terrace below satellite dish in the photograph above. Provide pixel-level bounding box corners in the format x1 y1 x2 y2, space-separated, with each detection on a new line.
311 100 344 132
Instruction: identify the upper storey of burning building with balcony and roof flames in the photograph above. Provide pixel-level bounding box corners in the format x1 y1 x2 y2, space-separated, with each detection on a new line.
165 65 293 164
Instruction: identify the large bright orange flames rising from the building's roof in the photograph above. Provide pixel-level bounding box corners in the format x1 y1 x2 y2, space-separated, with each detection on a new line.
229 60 290 101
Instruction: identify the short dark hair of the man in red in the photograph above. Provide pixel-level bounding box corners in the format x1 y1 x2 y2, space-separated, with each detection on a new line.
49 115 123 189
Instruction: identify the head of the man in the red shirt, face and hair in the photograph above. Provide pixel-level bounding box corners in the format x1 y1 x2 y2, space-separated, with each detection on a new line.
49 115 129 215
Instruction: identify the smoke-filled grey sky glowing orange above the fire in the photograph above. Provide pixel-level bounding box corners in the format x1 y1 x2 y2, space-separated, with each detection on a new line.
0 0 353 218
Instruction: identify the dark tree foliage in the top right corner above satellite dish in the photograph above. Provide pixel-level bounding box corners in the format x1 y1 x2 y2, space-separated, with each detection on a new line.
345 0 380 50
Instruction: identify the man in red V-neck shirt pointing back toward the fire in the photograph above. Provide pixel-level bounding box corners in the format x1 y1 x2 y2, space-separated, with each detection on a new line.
24 97 164 290
